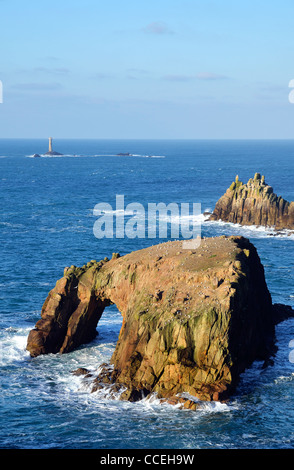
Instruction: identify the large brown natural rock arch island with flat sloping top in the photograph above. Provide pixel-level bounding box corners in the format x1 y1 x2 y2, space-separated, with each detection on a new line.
27 237 289 401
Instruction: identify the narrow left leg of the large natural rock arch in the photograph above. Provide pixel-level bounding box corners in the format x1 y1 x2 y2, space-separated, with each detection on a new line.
27 260 110 357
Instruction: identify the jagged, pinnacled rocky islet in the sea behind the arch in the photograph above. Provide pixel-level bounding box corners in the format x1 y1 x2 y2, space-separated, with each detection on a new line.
210 173 294 230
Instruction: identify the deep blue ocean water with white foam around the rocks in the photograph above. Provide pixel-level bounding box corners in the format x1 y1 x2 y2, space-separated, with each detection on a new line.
0 139 294 449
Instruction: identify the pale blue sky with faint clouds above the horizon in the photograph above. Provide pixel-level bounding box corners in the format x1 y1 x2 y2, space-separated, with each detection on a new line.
0 0 294 139
